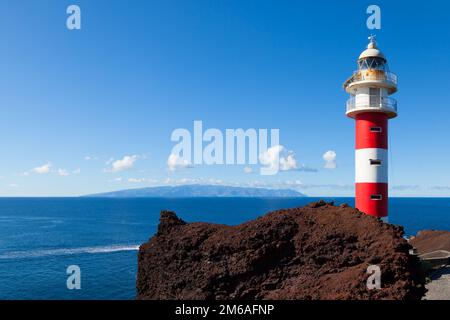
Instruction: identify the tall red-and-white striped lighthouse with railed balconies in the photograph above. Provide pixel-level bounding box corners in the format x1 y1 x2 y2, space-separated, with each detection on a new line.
344 36 397 222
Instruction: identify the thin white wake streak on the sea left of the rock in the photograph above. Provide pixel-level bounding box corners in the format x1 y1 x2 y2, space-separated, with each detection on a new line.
0 245 139 260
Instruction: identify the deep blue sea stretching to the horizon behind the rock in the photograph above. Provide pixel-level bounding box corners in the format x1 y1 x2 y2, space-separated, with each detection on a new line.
0 198 450 299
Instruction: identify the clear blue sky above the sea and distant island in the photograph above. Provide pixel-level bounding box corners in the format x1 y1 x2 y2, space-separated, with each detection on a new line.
0 0 450 196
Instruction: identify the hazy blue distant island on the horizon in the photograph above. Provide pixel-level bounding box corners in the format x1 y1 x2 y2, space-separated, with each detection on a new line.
85 184 306 198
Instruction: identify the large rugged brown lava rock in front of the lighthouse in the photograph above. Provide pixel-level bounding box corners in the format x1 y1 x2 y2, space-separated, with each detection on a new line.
137 201 425 299
